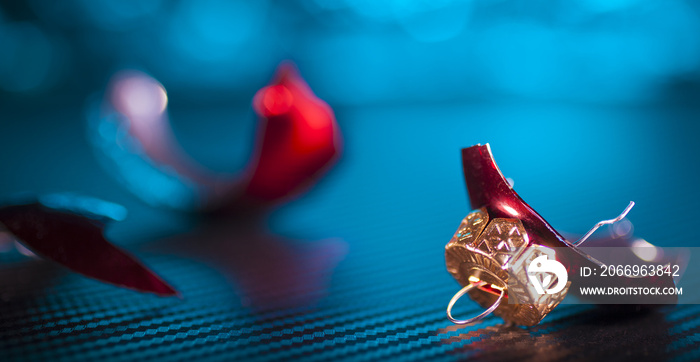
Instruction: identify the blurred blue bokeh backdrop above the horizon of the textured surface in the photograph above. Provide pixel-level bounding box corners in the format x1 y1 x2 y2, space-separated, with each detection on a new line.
0 0 700 105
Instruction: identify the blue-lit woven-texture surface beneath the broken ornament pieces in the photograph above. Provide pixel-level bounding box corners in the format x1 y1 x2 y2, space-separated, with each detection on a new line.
0 107 700 361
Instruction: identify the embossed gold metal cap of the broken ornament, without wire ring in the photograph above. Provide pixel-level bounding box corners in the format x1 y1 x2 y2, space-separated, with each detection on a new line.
445 208 568 326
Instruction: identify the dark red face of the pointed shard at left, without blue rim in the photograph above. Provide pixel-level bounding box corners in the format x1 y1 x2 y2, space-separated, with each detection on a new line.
0 203 179 296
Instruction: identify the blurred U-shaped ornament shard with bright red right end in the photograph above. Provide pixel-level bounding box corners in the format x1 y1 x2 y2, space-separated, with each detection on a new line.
88 62 342 213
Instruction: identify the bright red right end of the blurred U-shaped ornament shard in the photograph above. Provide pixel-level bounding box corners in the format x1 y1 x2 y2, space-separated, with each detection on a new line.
245 63 342 202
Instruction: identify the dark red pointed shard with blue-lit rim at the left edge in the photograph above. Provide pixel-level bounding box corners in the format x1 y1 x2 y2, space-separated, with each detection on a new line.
0 194 179 296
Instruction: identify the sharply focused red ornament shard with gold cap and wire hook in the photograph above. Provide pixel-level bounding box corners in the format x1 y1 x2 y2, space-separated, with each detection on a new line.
445 144 677 326
